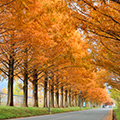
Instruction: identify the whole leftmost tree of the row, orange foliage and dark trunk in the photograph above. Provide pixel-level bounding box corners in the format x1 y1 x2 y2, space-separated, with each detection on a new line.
0 0 16 106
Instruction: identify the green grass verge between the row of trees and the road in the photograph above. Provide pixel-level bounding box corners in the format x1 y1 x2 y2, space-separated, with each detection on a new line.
0 106 91 119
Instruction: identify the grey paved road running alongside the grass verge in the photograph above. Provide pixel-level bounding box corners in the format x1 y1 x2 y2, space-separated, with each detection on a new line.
9 108 112 120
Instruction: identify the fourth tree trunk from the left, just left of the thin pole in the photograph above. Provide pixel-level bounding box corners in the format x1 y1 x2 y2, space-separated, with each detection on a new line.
43 72 48 107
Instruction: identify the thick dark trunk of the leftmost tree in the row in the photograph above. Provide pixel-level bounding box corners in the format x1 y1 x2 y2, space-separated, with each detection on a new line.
7 55 14 106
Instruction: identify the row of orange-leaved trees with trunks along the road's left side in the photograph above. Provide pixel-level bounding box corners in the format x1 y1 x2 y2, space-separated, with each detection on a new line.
0 0 112 107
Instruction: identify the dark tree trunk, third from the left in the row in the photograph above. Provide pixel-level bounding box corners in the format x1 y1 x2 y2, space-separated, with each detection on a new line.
33 69 38 107
